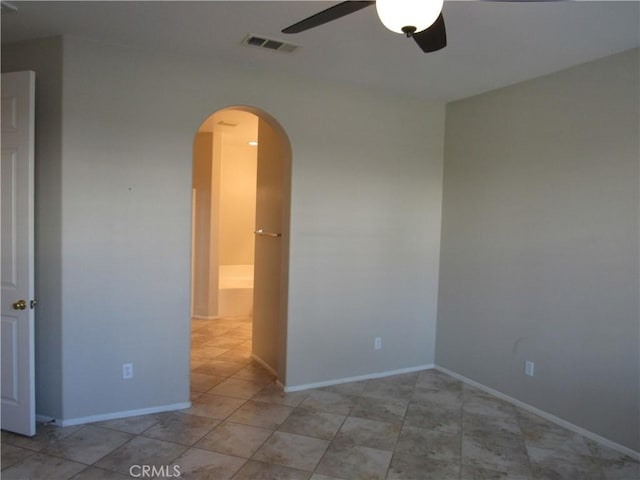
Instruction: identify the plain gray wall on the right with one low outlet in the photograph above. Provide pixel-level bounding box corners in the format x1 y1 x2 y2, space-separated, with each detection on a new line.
436 50 640 450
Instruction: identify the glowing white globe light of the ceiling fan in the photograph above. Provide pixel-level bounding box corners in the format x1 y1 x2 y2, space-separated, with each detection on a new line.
376 0 444 35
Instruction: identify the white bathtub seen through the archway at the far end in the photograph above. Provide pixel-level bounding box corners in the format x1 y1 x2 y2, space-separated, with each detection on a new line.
218 265 253 317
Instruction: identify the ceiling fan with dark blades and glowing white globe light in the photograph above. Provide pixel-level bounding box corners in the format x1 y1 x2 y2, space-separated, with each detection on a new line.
282 0 558 53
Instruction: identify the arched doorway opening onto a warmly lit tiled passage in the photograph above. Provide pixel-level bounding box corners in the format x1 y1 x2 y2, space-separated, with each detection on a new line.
192 106 291 384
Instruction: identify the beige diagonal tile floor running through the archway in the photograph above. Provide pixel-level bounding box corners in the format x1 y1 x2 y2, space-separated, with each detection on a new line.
1 318 640 480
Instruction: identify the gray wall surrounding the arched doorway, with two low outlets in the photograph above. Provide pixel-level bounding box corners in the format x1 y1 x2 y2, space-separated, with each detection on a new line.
2 37 444 420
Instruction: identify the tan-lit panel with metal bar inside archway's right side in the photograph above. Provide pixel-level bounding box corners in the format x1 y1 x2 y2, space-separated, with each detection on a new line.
253 119 284 372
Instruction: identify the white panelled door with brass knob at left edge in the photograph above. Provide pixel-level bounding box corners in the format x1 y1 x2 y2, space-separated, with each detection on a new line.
0 72 36 436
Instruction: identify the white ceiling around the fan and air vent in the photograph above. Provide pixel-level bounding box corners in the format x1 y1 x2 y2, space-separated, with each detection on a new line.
2 0 640 101
